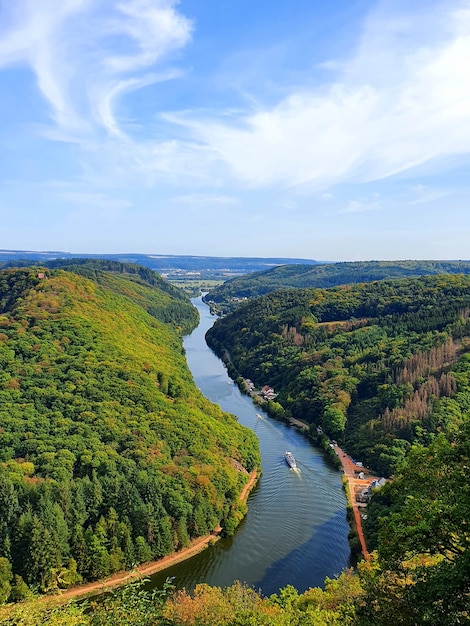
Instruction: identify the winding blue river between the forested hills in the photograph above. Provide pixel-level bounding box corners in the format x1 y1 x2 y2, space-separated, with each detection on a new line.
147 298 350 595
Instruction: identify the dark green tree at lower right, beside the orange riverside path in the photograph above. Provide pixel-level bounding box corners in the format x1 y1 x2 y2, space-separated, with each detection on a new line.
379 422 470 561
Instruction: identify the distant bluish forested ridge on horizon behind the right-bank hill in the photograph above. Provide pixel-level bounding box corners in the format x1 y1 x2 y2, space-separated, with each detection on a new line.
205 261 470 312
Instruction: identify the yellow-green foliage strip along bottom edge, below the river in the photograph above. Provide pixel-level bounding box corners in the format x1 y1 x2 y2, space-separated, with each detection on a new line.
0 572 364 626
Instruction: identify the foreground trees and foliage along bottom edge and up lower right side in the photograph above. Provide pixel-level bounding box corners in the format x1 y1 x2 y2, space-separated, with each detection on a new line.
0 388 470 626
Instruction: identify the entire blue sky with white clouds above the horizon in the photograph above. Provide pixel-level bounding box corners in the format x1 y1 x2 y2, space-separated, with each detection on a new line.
0 0 470 260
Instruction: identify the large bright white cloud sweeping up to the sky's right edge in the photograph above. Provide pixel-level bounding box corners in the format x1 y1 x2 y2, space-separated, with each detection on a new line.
173 0 470 187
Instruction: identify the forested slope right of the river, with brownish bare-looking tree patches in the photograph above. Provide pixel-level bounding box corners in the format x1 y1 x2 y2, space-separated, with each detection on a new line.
207 275 470 476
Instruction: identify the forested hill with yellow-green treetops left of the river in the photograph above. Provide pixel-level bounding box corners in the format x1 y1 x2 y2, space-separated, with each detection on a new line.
0 268 259 601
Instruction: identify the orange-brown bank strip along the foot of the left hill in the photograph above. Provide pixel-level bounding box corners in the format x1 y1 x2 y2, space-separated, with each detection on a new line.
41 470 261 603
